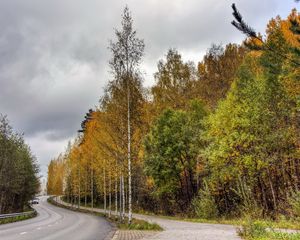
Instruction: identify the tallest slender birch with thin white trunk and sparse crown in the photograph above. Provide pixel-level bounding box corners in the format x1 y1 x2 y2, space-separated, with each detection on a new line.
109 7 145 224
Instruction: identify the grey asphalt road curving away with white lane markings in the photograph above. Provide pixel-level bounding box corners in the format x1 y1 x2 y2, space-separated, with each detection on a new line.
0 197 112 240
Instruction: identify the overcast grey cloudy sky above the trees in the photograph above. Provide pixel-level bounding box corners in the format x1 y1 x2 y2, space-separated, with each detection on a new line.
0 0 299 176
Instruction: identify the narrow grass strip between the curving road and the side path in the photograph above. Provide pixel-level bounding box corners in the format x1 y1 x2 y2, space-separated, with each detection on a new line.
47 197 163 231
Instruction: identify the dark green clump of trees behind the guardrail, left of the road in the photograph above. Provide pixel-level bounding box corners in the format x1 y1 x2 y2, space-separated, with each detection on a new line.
0 114 40 214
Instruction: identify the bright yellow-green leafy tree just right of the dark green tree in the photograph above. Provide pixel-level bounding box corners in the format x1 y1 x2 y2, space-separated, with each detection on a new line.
203 55 267 212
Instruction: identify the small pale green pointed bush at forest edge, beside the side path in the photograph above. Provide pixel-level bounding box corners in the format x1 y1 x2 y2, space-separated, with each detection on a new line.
192 184 218 219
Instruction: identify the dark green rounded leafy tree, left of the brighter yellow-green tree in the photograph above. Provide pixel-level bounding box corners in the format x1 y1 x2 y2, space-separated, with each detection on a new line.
145 101 205 213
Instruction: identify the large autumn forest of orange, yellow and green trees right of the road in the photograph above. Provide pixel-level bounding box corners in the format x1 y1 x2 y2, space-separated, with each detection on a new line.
48 6 300 222
